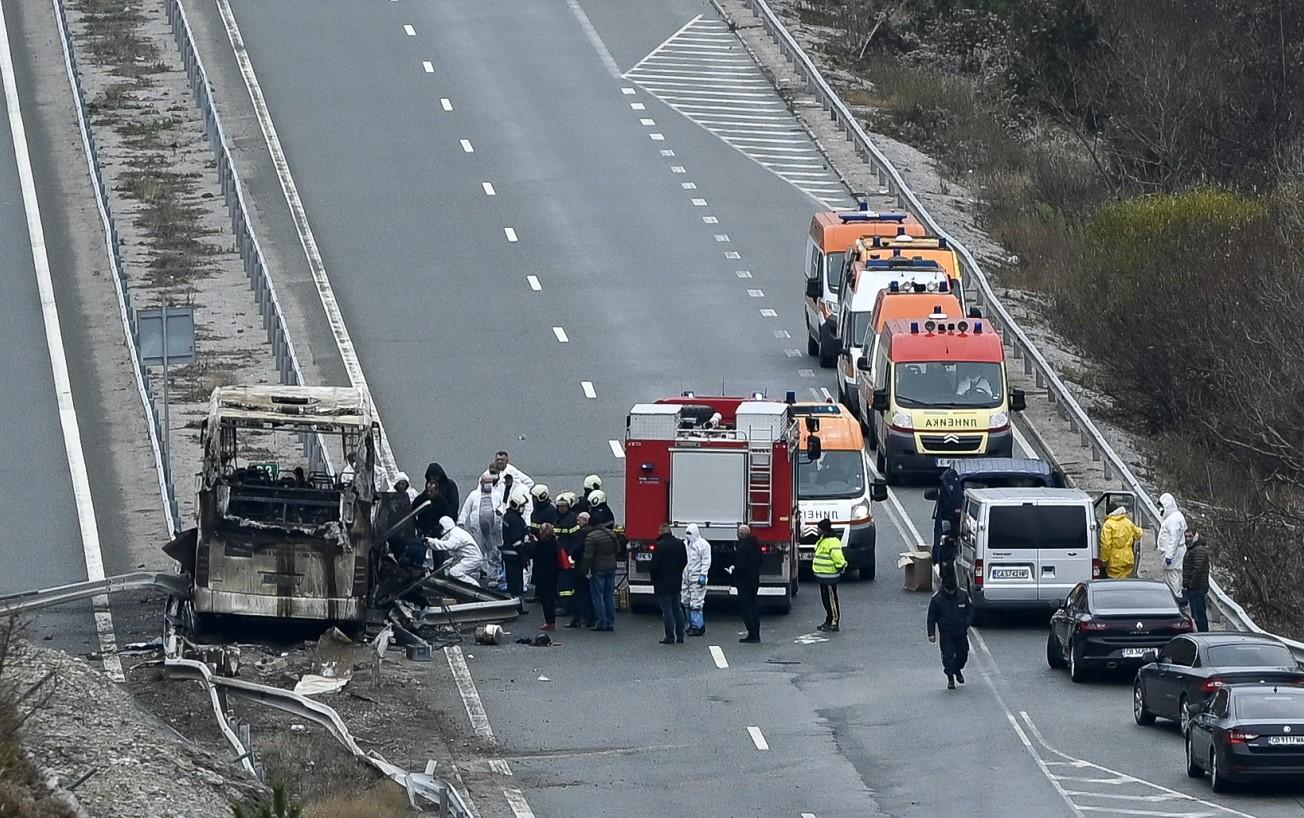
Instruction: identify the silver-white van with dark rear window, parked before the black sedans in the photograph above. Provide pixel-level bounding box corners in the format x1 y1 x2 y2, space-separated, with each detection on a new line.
956 488 1104 612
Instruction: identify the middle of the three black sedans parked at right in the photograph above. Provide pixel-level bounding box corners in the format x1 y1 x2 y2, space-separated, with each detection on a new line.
1132 633 1304 733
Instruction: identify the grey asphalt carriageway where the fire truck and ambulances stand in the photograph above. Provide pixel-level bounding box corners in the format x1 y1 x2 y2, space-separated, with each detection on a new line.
216 0 1300 817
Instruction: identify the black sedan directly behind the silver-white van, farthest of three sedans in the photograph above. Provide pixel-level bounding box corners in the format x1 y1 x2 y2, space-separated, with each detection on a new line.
1046 579 1196 682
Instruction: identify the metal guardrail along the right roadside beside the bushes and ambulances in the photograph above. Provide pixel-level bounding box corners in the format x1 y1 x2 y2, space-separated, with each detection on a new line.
746 0 1304 660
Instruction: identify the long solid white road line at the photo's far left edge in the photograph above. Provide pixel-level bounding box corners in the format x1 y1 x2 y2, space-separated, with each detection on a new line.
0 0 124 682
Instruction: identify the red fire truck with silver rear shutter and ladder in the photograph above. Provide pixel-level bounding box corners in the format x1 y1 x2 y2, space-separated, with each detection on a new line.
625 393 799 613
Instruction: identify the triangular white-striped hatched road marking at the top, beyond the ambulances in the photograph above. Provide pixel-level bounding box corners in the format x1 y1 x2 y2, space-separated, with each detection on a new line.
625 16 850 207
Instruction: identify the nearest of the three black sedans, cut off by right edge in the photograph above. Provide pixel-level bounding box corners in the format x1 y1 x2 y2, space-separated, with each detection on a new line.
1187 685 1304 792
